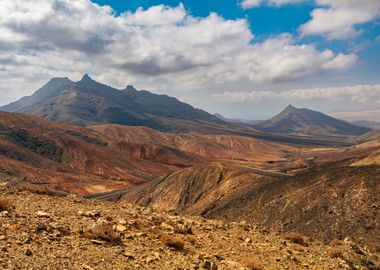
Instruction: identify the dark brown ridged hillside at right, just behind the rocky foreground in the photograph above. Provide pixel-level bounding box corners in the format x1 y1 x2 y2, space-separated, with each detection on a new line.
124 148 380 250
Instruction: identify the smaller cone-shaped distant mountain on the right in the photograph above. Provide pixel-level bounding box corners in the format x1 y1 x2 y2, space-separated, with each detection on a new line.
255 105 370 136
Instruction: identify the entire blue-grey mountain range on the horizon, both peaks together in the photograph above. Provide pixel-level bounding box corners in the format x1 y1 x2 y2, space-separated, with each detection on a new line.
0 74 370 137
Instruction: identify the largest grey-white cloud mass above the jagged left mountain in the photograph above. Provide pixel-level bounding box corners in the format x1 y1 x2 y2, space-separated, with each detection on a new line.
0 0 357 105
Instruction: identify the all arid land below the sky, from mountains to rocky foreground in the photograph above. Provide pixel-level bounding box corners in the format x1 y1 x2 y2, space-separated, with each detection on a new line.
0 76 380 270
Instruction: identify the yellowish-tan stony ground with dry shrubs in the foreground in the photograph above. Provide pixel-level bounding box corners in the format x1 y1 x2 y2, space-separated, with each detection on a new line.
0 188 379 269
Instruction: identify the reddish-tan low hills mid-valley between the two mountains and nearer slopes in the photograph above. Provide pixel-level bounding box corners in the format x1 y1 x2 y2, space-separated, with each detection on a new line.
89 125 297 166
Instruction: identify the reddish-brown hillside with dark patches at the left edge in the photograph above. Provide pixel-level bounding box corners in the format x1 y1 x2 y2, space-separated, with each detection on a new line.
0 112 202 194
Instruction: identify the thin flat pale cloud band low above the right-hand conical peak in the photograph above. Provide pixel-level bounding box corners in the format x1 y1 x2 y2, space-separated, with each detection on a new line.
212 84 380 104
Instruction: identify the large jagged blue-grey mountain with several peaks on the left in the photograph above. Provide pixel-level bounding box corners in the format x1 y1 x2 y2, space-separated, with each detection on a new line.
0 74 223 130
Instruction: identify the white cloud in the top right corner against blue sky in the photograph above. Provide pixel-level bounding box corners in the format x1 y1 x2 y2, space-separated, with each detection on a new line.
300 0 380 39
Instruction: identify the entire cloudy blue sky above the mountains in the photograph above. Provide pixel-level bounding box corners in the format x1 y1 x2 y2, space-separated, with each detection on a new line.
0 0 380 119
